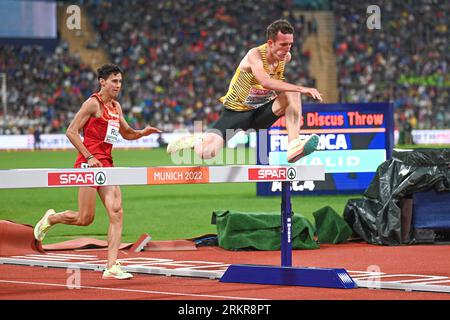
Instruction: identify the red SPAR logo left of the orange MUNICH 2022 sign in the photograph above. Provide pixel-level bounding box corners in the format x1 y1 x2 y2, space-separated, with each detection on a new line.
48 171 106 186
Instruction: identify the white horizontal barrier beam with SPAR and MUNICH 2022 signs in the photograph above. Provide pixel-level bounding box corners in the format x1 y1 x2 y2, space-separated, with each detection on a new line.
0 165 325 189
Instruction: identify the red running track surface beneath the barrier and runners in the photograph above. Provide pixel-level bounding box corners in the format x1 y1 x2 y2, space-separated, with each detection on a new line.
0 243 450 300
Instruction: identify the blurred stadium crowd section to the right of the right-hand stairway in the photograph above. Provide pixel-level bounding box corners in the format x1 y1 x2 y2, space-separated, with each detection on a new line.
333 0 450 129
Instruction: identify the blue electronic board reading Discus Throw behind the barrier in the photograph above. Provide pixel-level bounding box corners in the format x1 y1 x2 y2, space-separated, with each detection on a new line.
256 103 394 196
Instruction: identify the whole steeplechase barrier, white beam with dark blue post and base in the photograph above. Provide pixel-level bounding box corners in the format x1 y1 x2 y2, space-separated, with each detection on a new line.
0 165 357 289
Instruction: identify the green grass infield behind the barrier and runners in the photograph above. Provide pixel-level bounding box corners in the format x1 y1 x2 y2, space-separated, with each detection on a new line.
0 149 361 243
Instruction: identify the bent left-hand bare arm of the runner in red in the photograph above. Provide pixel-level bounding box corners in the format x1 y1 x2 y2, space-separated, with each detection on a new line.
66 98 101 167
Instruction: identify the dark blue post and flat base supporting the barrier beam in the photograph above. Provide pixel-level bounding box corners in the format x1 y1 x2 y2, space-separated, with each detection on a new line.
220 181 357 289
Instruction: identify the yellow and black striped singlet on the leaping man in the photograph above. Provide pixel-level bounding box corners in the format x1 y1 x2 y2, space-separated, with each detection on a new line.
219 44 286 111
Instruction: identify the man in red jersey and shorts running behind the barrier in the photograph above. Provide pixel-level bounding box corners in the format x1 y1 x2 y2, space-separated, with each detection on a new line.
34 64 161 279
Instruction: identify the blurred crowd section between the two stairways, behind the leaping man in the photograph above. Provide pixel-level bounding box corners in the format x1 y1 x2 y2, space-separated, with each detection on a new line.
83 0 309 130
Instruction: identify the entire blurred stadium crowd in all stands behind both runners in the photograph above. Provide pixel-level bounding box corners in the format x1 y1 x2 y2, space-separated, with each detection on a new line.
0 0 450 134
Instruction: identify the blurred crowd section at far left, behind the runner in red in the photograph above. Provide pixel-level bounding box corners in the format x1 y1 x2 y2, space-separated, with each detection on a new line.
0 42 98 134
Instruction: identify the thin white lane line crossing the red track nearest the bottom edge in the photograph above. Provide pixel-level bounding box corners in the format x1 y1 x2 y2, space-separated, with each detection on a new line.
0 280 268 300
